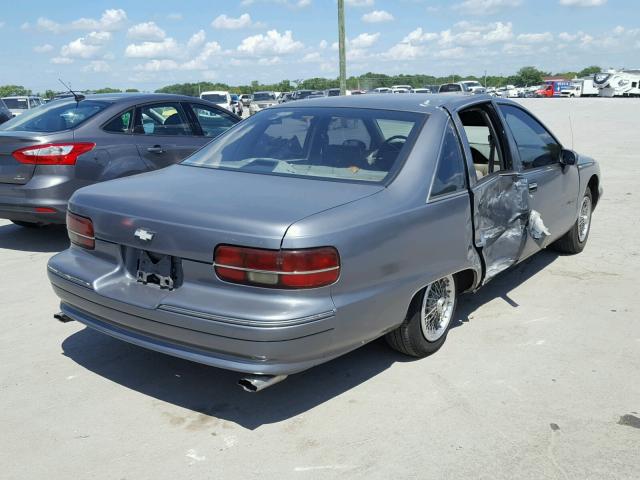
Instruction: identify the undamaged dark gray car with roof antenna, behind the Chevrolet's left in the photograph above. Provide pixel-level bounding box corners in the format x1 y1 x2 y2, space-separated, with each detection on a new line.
0 94 240 226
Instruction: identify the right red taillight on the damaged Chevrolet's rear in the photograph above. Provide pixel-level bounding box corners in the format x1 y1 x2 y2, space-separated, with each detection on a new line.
214 245 340 288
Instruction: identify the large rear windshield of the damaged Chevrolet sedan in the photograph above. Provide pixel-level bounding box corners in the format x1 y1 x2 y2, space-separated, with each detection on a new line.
183 107 425 182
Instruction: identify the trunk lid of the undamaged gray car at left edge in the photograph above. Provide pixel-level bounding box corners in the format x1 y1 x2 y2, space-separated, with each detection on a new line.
0 132 60 185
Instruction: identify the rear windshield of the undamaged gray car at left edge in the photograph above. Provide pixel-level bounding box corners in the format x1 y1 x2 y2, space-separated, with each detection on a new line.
0 99 109 133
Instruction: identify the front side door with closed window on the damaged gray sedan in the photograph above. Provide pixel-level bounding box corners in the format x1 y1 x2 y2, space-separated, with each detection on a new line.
498 103 579 257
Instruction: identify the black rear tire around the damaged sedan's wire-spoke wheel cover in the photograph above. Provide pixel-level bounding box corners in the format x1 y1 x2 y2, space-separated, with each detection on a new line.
385 276 458 358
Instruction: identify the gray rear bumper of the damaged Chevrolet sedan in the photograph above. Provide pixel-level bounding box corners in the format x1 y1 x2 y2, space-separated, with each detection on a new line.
48 267 362 375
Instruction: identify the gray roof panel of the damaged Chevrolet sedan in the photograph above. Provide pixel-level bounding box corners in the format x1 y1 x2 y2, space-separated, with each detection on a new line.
271 93 500 113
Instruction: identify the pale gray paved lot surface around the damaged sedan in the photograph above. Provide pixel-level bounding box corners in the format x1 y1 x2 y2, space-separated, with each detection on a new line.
0 98 640 480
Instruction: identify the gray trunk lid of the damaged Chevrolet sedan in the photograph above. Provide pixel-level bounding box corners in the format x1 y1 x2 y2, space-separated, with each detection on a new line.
69 165 384 262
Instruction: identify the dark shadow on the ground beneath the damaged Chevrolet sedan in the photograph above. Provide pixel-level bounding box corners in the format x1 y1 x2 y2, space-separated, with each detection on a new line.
62 252 557 430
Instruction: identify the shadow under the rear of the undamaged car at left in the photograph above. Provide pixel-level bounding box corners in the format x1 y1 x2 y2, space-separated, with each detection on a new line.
0 224 69 253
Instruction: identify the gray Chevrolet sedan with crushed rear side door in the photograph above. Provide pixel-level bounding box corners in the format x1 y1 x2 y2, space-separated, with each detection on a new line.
48 95 602 391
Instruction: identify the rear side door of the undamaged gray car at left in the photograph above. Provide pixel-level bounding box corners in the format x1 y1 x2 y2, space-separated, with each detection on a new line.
133 102 205 169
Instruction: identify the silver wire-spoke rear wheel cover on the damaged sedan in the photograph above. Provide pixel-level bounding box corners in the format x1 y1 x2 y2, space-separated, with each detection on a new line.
420 275 456 342
